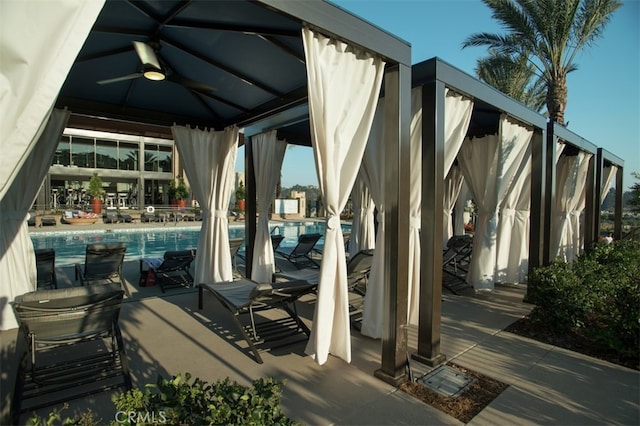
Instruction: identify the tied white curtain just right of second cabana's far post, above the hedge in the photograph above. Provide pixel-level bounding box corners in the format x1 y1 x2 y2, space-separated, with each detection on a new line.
551 151 592 262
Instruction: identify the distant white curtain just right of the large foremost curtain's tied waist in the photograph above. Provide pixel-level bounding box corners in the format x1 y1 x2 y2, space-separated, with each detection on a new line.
349 175 376 257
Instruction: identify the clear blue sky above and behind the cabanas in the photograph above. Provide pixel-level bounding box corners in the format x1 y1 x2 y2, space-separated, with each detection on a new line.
236 0 640 190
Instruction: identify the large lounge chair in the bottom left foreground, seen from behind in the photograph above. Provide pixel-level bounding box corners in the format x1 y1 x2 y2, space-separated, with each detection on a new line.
10 284 131 424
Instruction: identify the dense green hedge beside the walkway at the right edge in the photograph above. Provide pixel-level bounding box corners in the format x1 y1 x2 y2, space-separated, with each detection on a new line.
527 240 640 356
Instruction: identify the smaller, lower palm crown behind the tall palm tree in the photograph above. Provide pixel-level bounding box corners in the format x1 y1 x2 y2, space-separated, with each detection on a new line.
475 49 546 112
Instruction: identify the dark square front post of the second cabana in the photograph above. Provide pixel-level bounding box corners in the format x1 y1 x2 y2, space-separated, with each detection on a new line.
413 80 446 366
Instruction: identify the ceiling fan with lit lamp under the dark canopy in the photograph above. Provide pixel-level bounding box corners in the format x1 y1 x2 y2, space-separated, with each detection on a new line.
97 41 215 93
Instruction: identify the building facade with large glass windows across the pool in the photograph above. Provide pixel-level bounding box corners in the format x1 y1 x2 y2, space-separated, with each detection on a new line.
33 128 181 211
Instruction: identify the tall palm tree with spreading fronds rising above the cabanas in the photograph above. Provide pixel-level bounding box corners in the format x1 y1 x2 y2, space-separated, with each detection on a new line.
463 0 622 124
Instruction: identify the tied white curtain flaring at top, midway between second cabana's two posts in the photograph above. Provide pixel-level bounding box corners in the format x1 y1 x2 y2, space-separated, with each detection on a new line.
458 114 528 291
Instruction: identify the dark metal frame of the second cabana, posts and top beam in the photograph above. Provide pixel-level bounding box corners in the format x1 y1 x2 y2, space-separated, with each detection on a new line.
410 58 549 366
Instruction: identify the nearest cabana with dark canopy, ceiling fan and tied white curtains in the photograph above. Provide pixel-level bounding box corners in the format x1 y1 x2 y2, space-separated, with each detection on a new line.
0 0 411 378
